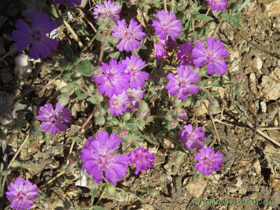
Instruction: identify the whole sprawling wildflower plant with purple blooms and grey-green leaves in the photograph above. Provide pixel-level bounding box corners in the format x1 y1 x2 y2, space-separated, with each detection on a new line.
0 0 252 209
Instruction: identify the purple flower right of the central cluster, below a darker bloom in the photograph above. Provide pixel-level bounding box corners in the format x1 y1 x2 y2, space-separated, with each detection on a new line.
165 66 199 100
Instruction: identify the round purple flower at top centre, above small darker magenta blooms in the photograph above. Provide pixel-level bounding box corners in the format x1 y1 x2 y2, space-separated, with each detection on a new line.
152 10 182 41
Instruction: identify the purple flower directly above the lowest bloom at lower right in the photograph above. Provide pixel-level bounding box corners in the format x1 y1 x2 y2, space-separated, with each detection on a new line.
179 124 205 149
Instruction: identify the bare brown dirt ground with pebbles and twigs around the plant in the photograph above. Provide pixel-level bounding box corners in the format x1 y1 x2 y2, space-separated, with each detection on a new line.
0 0 280 210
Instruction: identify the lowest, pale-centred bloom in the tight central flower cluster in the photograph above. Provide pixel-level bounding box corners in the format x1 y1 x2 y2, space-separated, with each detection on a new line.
108 90 130 116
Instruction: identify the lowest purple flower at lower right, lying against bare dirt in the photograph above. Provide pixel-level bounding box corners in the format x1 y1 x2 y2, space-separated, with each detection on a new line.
194 148 224 176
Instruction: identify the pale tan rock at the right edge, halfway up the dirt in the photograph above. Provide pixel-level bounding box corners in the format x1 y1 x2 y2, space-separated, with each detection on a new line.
257 76 280 100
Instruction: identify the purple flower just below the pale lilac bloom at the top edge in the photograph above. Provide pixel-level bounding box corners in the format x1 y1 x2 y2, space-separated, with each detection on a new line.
112 18 146 52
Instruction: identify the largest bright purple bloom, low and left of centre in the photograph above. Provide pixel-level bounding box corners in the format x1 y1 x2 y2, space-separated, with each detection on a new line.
81 131 129 185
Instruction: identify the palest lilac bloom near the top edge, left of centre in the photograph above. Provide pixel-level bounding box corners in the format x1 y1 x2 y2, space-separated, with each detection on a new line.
93 0 122 21
